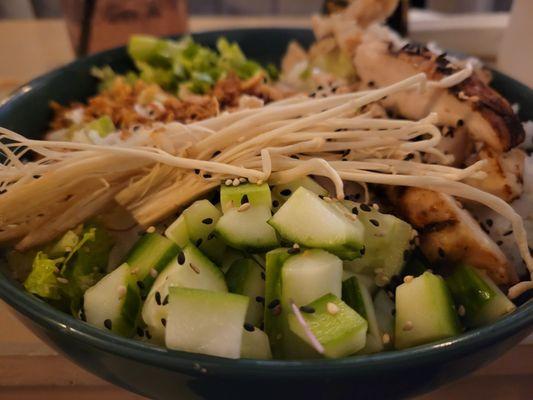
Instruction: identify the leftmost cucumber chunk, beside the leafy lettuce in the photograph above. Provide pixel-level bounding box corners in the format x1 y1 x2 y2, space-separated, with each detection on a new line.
83 264 141 337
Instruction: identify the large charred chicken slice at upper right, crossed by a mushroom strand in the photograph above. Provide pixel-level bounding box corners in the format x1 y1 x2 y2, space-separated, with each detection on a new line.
354 38 524 152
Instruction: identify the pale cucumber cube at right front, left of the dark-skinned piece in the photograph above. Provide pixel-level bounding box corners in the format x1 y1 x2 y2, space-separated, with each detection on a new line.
394 272 461 349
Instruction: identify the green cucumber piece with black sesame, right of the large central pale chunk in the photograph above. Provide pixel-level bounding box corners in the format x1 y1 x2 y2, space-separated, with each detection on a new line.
343 200 413 279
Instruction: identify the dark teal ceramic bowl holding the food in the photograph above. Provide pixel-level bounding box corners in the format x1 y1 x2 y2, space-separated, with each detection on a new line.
0 29 533 399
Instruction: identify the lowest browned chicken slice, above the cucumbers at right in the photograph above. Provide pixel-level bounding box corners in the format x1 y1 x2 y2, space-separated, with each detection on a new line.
389 187 518 285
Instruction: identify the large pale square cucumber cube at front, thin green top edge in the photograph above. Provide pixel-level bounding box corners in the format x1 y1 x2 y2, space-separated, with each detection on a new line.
165 287 248 358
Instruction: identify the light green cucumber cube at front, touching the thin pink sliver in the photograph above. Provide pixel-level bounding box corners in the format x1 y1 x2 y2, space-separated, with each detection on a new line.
289 294 368 358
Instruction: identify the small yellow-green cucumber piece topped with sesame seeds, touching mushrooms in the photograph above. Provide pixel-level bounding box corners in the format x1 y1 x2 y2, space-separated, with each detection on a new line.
220 183 272 214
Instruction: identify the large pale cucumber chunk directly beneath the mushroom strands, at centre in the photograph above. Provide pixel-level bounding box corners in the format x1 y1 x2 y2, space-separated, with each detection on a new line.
269 187 364 259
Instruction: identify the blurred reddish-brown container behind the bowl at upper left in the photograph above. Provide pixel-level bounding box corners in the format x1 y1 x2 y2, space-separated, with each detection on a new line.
62 0 188 56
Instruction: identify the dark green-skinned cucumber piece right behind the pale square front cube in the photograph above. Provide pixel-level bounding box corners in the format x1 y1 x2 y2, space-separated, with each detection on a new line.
226 258 265 326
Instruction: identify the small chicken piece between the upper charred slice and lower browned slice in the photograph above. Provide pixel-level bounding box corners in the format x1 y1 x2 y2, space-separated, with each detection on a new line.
465 148 525 203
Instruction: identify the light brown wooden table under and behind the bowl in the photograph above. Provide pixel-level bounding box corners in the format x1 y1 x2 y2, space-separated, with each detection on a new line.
0 17 533 400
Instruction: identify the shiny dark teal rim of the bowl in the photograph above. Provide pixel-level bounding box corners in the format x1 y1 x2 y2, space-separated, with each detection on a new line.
0 27 533 379
